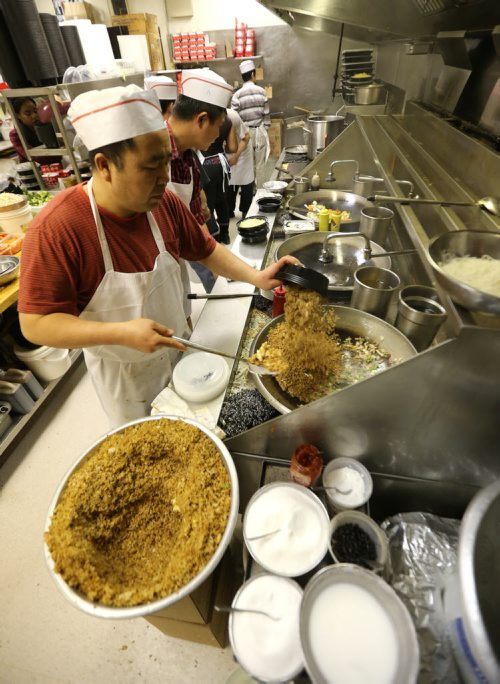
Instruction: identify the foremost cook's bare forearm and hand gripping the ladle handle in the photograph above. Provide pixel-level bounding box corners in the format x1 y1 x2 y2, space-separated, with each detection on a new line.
19 313 188 353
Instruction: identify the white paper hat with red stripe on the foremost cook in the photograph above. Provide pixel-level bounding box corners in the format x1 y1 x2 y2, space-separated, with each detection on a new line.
68 84 165 150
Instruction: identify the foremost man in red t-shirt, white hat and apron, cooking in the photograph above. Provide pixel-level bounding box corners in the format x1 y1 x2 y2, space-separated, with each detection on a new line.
18 85 293 427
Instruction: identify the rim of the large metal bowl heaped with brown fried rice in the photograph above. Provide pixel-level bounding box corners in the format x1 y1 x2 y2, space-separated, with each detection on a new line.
44 414 239 619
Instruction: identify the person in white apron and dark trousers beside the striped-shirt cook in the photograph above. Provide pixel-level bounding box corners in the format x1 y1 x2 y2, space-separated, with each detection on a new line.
226 109 255 218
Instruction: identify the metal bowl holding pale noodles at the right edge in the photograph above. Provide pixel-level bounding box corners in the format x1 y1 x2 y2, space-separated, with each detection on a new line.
428 230 500 316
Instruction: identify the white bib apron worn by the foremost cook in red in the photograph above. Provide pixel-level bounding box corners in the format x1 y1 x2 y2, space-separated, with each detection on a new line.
80 181 187 427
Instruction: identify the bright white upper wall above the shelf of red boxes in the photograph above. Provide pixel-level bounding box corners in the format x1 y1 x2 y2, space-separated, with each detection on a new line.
166 0 285 33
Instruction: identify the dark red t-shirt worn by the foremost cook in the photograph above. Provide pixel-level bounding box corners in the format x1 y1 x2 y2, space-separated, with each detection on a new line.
18 185 217 316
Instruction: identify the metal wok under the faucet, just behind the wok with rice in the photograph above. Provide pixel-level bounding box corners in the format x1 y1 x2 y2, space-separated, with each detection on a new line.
275 231 391 292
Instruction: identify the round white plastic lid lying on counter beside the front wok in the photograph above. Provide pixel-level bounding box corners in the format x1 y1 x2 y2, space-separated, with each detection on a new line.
172 352 229 402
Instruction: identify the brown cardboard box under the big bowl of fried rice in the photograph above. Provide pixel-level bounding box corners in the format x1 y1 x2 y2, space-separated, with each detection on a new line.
145 550 242 648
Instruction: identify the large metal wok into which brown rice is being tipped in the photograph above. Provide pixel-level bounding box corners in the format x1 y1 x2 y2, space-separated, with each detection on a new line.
250 305 417 413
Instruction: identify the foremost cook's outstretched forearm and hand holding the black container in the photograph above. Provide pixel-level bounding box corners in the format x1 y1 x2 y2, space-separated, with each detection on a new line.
201 244 300 290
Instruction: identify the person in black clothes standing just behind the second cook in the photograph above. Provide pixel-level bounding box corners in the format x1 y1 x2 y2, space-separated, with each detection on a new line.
198 110 238 245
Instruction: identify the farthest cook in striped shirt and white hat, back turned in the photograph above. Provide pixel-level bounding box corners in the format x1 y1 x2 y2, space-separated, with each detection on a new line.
231 59 271 176
